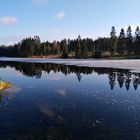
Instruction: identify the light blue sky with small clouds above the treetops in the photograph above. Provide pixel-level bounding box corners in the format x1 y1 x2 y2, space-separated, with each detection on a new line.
0 0 140 44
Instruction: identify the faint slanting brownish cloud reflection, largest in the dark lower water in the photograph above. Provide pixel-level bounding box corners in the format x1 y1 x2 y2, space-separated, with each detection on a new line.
39 104 55 117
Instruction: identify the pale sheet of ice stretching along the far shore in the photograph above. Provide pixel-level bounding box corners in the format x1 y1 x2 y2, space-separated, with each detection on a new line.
0 58 140 73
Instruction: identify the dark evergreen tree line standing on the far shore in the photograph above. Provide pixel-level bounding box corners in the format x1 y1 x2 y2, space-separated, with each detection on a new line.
0 26 140 58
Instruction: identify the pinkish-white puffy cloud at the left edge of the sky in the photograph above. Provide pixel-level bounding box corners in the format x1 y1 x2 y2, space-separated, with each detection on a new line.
0 16 17 25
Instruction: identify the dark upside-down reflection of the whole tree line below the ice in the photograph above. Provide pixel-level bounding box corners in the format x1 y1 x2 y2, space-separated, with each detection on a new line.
0 62 140 90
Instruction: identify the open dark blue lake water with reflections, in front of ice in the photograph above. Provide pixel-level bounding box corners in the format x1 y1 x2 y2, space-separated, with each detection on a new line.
0 62 140 140
